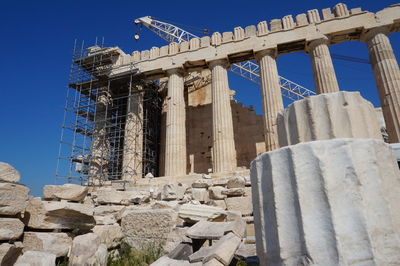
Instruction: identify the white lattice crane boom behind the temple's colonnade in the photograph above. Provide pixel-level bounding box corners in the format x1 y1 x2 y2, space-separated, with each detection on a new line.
135 16 316 101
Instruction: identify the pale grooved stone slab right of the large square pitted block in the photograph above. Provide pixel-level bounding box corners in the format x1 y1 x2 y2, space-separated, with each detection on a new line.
178 203 226 223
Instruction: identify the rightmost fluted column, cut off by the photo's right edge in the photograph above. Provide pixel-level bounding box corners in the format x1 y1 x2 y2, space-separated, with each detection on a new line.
363 28 400 143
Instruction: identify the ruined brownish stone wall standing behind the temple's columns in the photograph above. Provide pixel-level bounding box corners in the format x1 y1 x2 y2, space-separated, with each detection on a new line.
160 70 265 176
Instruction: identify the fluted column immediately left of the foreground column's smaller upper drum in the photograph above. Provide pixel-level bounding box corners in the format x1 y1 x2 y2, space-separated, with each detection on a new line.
256 49 284 151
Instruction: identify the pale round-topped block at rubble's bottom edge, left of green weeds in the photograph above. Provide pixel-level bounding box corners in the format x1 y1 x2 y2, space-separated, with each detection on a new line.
69 233 107 266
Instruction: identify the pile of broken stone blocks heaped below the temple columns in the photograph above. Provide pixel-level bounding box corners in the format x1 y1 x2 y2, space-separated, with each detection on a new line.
0 163 255 266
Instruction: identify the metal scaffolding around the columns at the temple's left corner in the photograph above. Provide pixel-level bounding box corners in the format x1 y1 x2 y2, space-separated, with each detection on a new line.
56 41 162 185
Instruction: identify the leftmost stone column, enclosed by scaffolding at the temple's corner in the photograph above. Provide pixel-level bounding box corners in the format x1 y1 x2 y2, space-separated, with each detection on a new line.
88 91 112 182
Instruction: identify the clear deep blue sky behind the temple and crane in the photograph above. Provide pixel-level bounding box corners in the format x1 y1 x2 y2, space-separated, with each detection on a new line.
0 0 400 196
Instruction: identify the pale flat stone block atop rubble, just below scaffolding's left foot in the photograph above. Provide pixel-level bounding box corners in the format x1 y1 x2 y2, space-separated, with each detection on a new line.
43 184 88 201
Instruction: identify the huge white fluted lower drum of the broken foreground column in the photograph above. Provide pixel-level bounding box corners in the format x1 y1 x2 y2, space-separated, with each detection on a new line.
251 139 400 265
